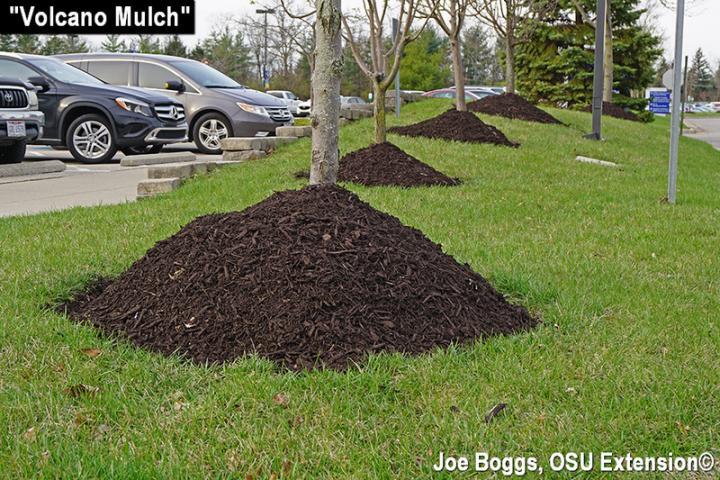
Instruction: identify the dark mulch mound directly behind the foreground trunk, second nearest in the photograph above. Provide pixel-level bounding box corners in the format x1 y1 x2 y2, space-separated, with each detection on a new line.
295 142 460 187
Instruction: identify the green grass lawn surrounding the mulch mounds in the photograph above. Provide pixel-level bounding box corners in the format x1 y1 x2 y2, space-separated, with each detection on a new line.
0 101 720 479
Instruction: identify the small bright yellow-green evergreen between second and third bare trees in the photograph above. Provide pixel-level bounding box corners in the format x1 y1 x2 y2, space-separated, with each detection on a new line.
400 28 452 91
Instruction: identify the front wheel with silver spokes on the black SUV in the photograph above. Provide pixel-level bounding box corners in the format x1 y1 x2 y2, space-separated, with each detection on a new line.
65 113 117 163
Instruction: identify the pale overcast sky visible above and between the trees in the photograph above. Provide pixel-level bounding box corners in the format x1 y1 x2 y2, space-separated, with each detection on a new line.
97 0 720 69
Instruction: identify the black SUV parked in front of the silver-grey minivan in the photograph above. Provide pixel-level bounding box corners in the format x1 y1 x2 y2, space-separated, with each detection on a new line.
0 53 187 163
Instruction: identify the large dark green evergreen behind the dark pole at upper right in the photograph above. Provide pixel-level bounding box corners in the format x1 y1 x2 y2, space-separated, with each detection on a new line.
516 0 661 110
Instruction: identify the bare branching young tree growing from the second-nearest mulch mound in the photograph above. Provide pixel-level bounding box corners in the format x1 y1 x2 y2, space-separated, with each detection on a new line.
342 0 428 143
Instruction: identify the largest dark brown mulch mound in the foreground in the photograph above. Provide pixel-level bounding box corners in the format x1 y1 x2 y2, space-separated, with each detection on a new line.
60 185 537 370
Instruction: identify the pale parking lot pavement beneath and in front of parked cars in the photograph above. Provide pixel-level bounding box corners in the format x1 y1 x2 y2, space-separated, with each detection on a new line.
0 143 221 217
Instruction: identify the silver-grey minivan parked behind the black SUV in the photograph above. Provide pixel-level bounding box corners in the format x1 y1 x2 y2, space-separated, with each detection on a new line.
57 53 293 154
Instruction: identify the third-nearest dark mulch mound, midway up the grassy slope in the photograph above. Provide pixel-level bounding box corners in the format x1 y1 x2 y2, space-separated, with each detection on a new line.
388 109 519 147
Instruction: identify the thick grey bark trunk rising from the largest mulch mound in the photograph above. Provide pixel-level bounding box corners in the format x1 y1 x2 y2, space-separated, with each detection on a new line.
310 0 343 185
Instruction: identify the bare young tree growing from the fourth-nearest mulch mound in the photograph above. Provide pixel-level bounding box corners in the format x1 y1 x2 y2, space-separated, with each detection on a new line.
475 0 555 93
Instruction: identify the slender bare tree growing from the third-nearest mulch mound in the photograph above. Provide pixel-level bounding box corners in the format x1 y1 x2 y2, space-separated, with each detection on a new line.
422 0 473 111
